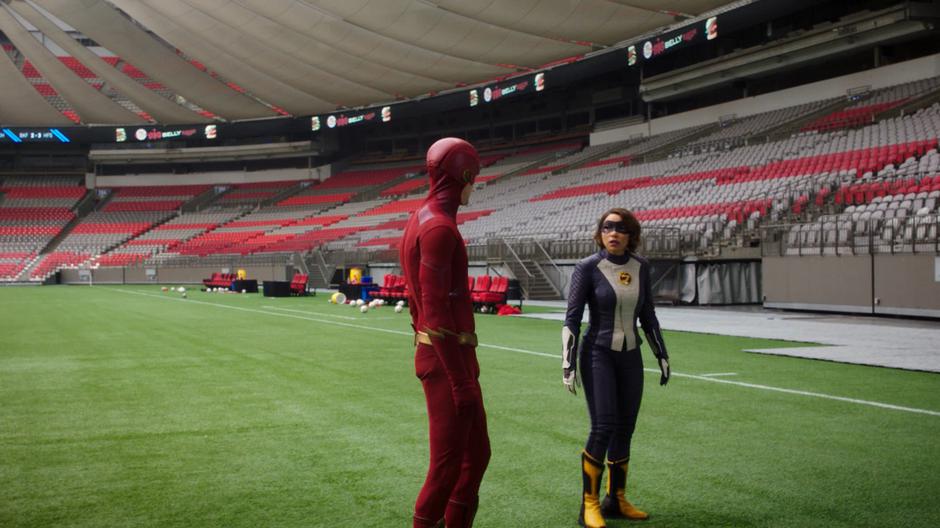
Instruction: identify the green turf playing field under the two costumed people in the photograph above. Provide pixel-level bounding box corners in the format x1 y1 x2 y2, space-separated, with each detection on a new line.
0 286 940 528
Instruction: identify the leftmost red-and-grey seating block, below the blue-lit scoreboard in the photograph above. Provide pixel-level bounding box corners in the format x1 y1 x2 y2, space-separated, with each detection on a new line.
0 176 86 281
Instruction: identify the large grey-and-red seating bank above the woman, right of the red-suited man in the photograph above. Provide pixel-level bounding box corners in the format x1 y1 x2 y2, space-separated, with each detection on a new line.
462 95 940 250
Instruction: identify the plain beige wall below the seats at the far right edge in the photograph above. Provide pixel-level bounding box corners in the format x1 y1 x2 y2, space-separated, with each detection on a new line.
763 254 940 317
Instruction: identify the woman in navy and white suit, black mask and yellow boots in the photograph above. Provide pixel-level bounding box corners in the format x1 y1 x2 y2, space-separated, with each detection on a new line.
562 208 670 528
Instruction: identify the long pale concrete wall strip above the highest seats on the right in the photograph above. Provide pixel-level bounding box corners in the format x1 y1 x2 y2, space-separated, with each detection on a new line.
591 54 940 145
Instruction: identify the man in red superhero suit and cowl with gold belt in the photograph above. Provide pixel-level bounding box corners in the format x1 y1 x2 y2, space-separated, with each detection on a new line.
400 138 490 528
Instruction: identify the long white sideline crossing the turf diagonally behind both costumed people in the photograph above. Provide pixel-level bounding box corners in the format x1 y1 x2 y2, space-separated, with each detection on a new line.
112 287 940 416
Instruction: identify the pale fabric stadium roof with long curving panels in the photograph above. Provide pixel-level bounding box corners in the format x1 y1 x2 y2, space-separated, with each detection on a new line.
0 0 748 125
